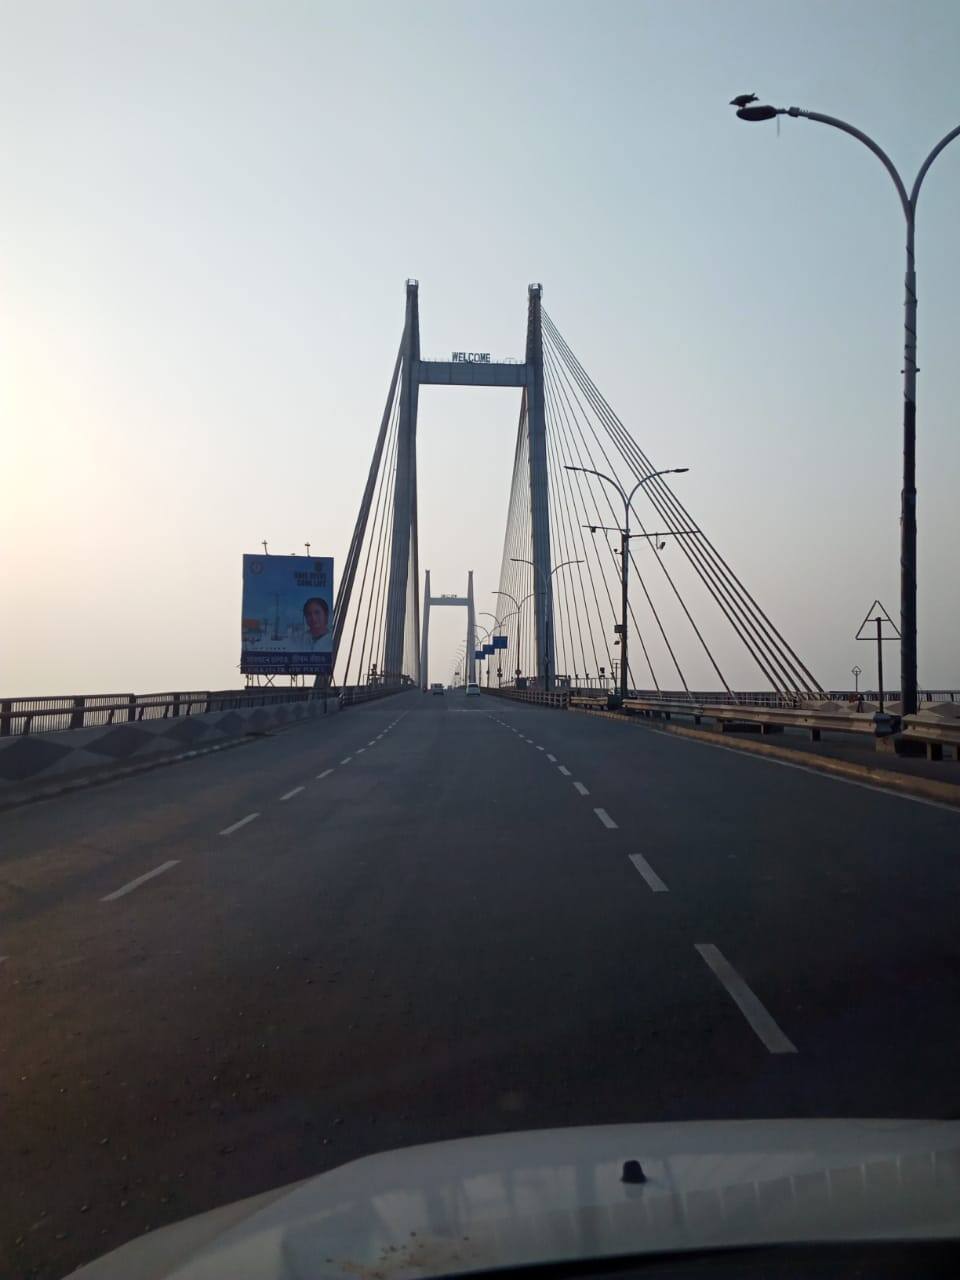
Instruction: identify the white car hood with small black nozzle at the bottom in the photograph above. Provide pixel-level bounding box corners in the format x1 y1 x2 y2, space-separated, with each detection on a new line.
73 1120 960 1280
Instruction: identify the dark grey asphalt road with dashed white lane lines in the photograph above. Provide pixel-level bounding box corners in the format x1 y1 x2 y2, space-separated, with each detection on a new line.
0 692 960 1277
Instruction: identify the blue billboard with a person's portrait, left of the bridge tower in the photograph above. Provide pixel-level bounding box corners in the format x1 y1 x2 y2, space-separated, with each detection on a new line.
241 556 334 676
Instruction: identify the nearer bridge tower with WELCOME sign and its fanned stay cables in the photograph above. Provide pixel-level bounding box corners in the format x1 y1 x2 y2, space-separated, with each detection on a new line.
334 280 823 699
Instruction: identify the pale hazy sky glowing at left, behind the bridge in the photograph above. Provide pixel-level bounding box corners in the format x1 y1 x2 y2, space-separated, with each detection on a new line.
0 0 960 695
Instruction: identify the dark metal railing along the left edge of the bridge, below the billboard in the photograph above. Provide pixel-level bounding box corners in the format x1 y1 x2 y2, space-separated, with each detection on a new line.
0 685 407 737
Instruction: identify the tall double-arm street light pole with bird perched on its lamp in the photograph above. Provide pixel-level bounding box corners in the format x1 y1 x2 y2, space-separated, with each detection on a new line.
737 105 960 716
